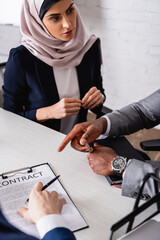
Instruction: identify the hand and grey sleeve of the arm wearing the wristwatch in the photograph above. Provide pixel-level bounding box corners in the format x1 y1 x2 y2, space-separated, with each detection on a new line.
87 143 160 198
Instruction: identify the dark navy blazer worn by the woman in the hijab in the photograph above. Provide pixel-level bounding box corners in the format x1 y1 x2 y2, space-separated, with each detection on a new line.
3 40 105 131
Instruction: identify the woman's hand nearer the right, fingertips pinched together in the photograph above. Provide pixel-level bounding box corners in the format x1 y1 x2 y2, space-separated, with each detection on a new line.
82 87 104 109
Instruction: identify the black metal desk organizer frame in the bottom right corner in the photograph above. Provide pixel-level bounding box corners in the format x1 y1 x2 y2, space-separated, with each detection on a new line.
109 173 160 240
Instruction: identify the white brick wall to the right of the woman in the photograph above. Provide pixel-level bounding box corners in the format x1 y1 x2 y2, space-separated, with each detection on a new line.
76 0 160 109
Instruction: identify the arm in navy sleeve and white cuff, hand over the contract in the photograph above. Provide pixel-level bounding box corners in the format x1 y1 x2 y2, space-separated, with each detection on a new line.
0 183 75 240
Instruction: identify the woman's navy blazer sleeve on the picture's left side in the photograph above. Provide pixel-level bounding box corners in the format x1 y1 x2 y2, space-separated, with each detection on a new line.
3 49 36 121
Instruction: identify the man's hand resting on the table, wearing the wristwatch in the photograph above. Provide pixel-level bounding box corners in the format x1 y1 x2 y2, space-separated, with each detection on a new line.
87 143 118 176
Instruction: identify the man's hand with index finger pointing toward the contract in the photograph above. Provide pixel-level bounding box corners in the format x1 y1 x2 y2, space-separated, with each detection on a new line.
58 117 107 152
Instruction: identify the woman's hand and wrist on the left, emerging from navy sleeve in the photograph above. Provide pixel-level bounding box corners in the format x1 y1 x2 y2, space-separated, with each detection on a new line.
36 98 82 122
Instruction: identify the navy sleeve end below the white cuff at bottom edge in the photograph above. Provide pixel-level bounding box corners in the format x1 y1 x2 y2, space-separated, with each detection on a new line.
42 227 76 240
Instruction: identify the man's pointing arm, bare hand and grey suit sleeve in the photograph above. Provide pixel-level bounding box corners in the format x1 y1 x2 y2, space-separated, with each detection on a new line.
58 89 160 152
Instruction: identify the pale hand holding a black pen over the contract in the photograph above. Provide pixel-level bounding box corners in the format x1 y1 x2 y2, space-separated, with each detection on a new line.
17 182 66 223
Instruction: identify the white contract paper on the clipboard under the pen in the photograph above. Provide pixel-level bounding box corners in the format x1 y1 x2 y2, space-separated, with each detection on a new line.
0 163 88 238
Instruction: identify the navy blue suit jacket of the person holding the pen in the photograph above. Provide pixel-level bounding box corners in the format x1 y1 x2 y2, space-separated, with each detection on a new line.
0 211 75 240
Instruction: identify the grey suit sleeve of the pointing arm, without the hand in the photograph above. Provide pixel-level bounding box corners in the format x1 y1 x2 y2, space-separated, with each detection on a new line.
107 89 160 136
